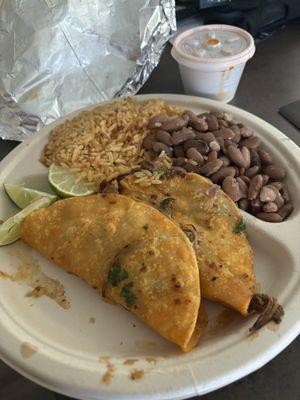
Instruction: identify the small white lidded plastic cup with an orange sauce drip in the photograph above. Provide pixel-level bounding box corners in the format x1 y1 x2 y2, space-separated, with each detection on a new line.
171 25 255 103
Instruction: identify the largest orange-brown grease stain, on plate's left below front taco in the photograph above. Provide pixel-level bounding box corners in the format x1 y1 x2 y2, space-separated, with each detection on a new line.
0 244 70 309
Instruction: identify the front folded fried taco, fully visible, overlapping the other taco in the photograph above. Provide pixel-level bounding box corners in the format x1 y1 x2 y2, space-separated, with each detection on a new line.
21 194 200 351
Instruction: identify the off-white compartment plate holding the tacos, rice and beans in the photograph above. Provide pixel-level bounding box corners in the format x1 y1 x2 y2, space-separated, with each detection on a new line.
0 94 300 400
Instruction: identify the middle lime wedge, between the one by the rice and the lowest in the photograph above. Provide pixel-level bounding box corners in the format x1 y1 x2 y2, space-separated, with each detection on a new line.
4 183 57 209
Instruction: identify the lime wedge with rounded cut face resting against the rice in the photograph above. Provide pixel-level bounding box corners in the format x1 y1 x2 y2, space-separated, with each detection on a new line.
48 164 95 198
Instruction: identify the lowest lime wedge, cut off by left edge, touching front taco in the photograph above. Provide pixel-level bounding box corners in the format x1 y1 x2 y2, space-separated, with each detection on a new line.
0 197 51 246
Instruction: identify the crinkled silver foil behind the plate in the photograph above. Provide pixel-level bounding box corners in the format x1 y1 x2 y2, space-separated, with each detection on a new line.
0 0 176 140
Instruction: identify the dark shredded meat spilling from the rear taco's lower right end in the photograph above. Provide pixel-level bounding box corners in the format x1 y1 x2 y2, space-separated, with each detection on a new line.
248 293 284 332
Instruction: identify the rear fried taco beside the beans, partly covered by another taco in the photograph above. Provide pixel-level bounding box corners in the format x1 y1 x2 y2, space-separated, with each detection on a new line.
119 173 255 316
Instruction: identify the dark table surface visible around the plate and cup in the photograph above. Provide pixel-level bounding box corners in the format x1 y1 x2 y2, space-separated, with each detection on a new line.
0 23 300 400
